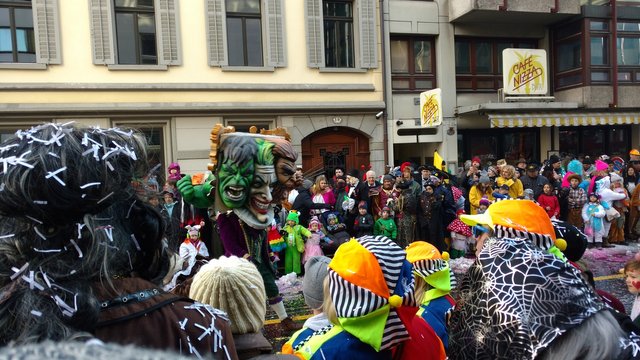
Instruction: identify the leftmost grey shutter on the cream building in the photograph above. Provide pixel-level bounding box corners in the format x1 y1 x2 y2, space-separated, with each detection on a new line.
32 0 62 64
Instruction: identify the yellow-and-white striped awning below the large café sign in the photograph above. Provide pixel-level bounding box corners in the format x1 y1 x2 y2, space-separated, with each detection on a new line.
489 113 640 128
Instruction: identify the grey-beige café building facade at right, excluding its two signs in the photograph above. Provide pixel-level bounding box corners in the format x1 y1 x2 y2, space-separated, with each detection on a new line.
382 0 640 171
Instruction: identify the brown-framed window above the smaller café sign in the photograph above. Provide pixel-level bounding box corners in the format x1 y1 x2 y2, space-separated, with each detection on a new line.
390 37 436 91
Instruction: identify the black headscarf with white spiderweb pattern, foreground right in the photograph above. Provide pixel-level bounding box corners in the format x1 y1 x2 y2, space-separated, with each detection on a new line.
449 238 604 360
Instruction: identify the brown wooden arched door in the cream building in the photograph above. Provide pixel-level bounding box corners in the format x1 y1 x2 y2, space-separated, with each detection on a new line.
301 127 369 178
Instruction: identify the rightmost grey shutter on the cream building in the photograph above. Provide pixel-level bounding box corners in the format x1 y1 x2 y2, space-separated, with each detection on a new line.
357 0 378 69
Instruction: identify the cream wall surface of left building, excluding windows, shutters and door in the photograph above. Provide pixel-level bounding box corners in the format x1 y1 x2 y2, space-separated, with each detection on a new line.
0 0 385 173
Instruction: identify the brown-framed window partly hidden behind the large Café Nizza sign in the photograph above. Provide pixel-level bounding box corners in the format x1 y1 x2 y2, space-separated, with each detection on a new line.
455 38 537 92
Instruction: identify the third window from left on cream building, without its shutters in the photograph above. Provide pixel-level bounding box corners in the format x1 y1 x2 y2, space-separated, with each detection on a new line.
226 0 262 66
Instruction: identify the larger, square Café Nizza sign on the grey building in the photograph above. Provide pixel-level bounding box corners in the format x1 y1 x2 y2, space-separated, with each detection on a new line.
502 49 548 95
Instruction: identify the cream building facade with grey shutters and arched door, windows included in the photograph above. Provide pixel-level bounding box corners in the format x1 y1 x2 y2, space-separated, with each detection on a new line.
0 0 388 180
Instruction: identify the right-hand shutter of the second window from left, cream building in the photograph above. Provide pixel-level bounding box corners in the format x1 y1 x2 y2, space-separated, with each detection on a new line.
155 0 182 65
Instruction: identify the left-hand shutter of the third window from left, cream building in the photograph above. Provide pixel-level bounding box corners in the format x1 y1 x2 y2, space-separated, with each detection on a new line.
205 0 229 66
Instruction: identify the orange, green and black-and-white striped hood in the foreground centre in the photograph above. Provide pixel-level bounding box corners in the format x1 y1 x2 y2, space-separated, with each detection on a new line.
329 236 416 351
